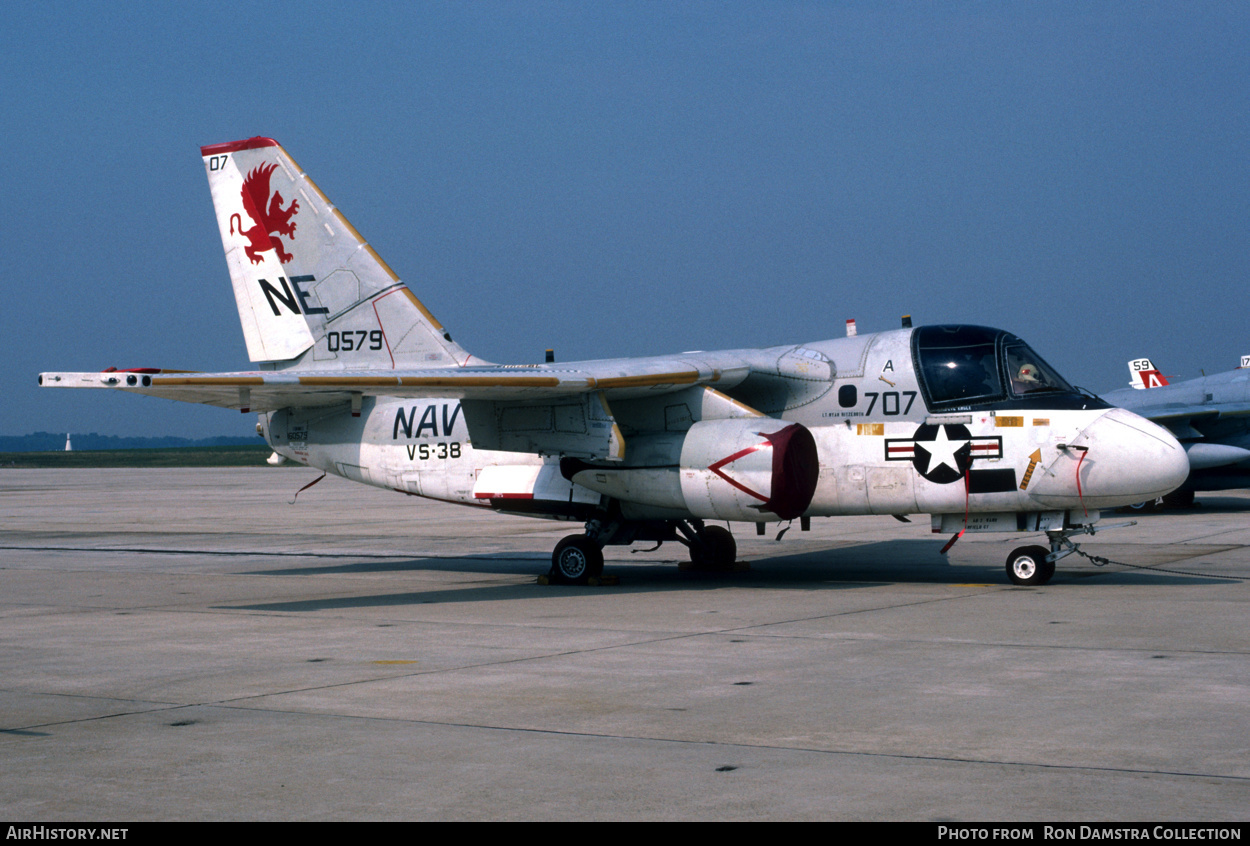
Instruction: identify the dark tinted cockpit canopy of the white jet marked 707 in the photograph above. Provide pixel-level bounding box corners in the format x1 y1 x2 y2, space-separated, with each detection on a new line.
911 326 1105 411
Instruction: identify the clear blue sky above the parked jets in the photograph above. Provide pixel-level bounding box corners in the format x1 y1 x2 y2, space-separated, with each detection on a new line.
0 1 1250 437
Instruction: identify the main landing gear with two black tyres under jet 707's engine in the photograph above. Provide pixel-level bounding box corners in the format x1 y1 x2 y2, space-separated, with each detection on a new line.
548 520 738 585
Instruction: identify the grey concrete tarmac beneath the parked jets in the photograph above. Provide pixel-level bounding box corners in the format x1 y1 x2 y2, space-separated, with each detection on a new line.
0 469 1250 824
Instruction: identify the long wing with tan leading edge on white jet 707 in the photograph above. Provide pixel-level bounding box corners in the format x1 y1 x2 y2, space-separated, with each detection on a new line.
39 357 749 412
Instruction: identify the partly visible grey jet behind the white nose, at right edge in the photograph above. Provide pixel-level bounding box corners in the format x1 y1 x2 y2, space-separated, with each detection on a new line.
1103 355 1250 510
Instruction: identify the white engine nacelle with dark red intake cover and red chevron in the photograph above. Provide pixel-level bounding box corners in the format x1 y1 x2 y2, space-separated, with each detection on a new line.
564 417 820 522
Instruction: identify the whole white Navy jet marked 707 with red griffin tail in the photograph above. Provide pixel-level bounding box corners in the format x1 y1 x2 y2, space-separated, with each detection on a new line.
39 137 1189 585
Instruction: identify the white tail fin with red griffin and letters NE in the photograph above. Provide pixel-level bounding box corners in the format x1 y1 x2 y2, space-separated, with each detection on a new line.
200 137 472 370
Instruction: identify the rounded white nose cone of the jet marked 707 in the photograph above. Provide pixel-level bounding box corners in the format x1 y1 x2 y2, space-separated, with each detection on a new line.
1034 409 1189 509
